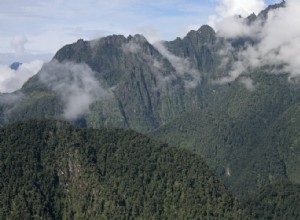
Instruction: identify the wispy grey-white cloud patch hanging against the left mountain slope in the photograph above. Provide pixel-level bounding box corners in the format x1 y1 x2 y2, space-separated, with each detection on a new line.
39 60 111 120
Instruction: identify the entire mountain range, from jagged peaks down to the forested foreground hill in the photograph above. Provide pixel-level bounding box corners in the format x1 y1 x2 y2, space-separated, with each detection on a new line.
0 1 300 219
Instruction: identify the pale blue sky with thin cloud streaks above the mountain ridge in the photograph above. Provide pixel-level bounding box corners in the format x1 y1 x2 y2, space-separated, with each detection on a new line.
0 0 280 64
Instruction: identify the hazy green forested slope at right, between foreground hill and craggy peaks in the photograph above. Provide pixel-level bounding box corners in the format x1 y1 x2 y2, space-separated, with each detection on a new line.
151 70 300 195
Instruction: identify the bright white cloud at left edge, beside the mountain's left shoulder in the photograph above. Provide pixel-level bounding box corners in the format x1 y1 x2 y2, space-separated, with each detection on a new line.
0 60 43 93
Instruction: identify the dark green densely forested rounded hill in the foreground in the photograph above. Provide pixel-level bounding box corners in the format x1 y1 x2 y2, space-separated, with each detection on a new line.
0 121 244 219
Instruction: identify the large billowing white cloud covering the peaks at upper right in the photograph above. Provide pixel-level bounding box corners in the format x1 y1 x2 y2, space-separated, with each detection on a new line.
213 0 300 83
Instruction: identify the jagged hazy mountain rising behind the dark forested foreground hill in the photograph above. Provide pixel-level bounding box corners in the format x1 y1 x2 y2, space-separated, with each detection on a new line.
0 0 300 199
